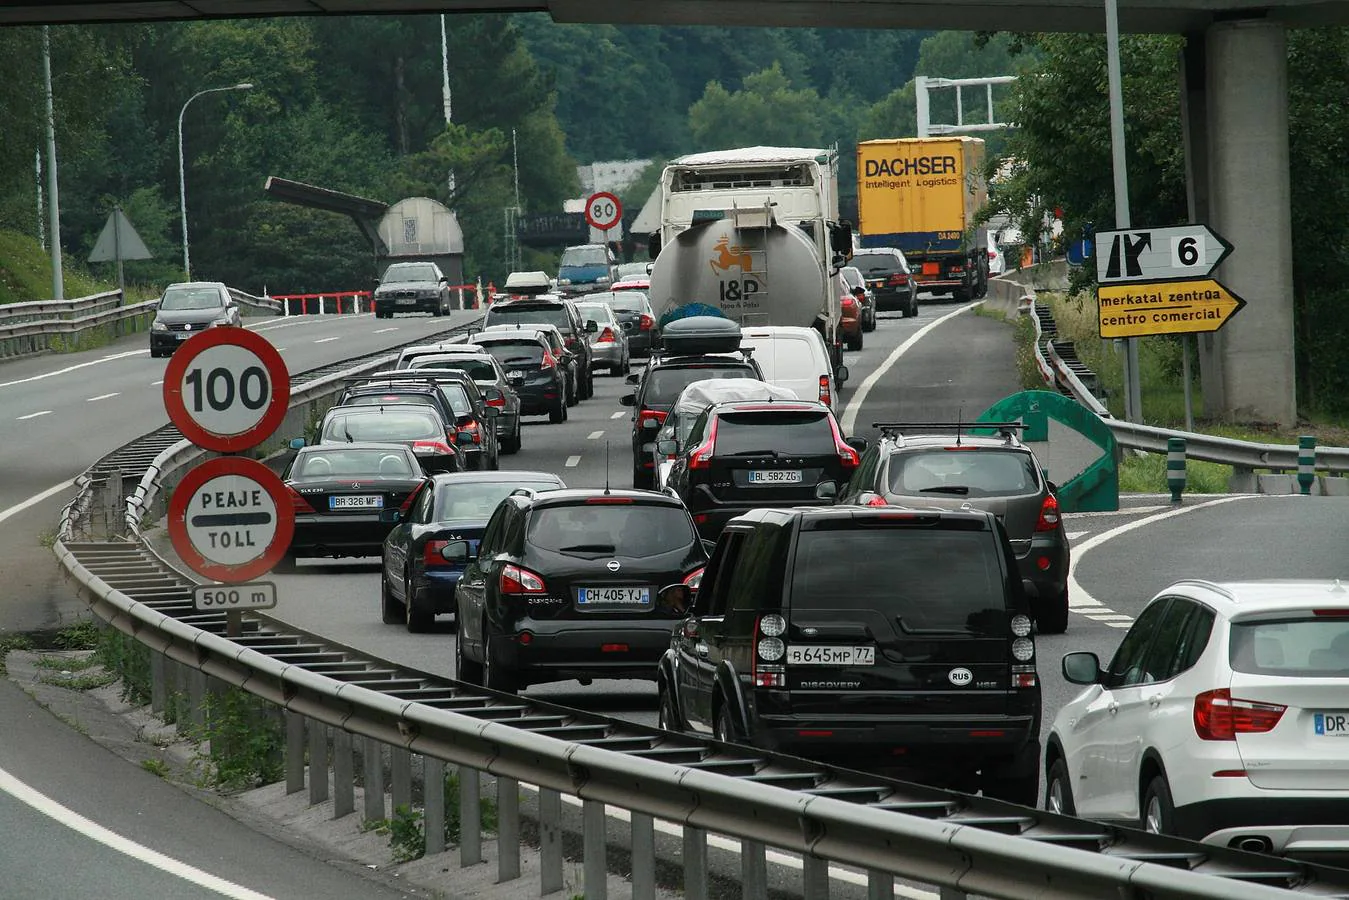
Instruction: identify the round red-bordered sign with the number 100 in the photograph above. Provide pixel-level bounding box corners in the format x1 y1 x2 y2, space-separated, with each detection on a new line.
163 327 290 453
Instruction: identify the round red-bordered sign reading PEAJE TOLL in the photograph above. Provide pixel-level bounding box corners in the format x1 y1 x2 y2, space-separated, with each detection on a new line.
169 456 295 584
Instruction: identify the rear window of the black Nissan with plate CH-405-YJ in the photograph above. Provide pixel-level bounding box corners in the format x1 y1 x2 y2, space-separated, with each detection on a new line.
529 503 697 556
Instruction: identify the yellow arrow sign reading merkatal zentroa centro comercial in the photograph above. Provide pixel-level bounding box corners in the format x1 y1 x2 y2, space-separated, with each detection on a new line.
1097 278 1246 337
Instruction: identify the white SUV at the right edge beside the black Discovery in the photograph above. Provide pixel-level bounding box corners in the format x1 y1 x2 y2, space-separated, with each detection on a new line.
1044 580 1349 855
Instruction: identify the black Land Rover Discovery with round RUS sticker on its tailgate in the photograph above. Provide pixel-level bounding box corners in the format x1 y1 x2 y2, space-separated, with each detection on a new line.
657 506 1040 806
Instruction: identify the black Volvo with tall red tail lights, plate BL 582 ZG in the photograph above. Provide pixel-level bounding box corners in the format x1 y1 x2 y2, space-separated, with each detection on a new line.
656 399 866 540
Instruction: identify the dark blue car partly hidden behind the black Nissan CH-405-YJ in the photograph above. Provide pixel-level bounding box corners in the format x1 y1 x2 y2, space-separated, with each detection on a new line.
379 471 567 631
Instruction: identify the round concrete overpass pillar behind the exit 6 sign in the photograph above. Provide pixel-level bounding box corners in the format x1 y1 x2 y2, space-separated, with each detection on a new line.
1205 19 1298 425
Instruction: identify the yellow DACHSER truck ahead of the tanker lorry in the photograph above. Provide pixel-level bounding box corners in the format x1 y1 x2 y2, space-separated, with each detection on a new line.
857 136 989 300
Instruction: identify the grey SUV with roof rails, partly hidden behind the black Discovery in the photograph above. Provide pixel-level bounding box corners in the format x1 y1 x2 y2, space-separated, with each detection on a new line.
838 422 1068 634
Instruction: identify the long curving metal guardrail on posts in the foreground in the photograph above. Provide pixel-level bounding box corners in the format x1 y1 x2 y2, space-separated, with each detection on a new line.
44 322 1349 900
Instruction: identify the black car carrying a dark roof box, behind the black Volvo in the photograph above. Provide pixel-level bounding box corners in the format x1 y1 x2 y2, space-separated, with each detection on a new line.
618 316 764 490
